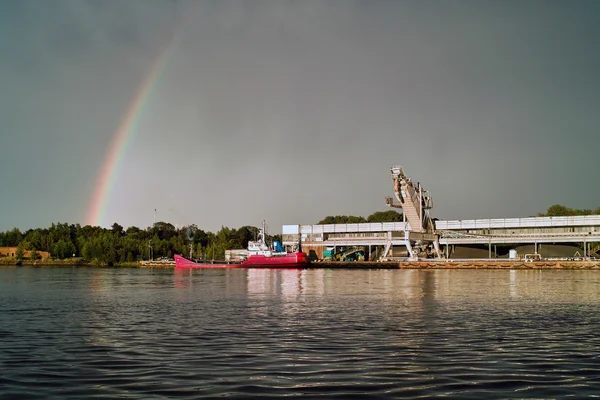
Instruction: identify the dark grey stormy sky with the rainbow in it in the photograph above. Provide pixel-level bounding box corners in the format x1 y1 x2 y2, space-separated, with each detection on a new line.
0 0 600 233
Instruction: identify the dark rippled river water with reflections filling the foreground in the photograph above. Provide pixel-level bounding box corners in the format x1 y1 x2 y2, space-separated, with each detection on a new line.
0 267 600 399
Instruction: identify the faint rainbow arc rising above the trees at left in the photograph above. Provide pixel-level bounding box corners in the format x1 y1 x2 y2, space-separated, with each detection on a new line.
85 34 177 226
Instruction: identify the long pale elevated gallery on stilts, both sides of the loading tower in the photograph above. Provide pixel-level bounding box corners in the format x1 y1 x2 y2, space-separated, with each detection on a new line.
282 215 600 256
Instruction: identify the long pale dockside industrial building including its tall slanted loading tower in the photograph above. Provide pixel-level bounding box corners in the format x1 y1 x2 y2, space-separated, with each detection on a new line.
282 166 600 261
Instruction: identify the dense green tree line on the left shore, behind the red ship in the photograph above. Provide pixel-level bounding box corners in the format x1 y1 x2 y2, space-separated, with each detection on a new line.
0 222 268 265
